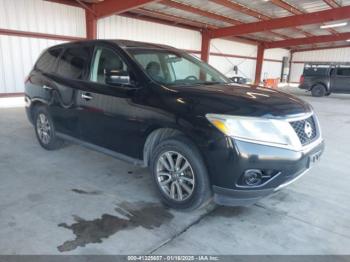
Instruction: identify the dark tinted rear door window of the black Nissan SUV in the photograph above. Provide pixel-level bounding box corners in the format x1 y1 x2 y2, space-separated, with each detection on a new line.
57 47 91 79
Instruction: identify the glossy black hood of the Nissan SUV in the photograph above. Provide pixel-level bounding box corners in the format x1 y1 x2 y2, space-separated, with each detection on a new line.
168 84 312 117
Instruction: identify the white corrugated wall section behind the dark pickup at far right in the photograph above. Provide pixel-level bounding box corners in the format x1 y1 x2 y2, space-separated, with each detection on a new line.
290 47 350 82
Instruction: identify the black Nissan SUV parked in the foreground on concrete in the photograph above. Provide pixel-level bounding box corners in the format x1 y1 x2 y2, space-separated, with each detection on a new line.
25 40 324 208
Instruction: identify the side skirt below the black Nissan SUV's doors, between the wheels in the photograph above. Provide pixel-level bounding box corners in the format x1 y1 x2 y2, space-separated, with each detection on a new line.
56 132 147 167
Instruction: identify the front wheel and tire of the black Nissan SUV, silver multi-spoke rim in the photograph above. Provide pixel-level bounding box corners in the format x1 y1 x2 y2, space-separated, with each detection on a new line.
151 136 211 210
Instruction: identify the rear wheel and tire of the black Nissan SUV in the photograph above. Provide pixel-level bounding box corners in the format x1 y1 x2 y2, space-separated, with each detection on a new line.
33 106 63 150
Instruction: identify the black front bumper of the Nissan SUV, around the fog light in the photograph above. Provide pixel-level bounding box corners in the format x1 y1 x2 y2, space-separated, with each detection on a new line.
209 139 325 206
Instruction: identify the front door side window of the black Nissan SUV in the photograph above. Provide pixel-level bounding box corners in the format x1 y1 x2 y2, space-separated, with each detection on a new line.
90 48 128 84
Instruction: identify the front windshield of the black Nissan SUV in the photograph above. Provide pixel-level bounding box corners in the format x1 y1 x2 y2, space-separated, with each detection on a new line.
127 48 230 86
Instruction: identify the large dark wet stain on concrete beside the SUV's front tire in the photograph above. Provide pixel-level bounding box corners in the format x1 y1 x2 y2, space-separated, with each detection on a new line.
57 202 174 252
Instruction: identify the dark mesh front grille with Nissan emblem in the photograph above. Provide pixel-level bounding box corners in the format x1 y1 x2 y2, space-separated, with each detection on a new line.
290 116 318 146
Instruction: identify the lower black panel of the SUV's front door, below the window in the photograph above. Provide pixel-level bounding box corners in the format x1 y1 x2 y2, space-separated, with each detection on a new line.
78 87 142 158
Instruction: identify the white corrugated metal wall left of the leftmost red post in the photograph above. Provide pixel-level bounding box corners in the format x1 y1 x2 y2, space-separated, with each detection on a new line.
0 0 85 94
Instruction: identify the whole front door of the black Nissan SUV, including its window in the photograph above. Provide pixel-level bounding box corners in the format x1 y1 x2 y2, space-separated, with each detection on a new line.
78 47 143 158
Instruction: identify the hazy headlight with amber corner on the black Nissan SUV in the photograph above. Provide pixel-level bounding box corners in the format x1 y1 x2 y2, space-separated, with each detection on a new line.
206 114 301 149
